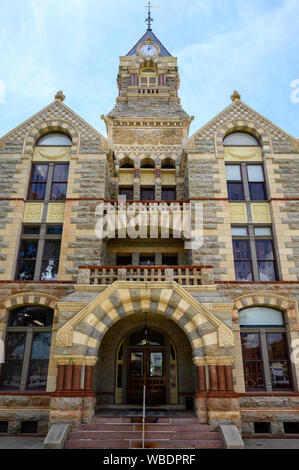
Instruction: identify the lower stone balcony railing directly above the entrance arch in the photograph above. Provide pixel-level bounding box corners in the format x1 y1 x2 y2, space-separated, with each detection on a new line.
77 266 214 286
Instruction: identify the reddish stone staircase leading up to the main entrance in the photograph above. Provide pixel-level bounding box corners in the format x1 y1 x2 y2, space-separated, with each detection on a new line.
65 416 223 449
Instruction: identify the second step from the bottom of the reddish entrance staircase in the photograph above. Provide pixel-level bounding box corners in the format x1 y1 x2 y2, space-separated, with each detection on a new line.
69 430 220 441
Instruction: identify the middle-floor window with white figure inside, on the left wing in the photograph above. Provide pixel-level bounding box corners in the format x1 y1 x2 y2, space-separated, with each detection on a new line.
16 224 62 281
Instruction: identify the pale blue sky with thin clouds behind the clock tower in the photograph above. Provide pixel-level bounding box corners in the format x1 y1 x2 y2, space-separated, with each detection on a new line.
0 0 299 137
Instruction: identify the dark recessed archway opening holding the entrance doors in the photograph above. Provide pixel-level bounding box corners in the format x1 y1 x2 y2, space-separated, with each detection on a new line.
94 313 196 408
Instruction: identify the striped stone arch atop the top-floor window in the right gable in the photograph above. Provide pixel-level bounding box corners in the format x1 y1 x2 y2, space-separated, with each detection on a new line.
214 119 272 157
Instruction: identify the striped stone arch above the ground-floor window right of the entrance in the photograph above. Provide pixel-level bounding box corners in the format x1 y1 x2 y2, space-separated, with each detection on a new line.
233 292 299 323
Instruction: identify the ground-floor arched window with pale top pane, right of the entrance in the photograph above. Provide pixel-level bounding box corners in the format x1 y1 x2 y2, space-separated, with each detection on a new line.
239 306 292 391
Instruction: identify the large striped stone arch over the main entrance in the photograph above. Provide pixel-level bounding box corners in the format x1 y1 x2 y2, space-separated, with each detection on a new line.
56 281 234 357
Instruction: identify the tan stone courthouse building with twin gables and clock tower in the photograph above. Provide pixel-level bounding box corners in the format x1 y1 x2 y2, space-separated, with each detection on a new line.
0 23 299 446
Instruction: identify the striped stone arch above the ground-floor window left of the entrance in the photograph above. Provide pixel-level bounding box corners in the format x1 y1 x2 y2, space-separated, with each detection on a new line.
0 292 57 322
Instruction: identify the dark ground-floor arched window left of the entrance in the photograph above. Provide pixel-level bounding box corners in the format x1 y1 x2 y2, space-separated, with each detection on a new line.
0 305 53 391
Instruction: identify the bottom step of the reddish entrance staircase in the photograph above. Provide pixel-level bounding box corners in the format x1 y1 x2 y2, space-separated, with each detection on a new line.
65 439 223 449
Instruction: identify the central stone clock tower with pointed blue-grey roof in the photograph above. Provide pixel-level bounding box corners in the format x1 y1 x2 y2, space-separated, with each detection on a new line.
102 27 193 200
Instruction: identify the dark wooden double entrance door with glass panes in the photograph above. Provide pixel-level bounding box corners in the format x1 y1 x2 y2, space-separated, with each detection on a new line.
127 347 166 405
